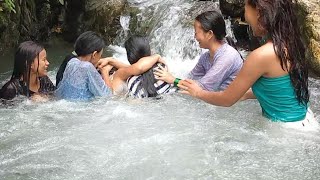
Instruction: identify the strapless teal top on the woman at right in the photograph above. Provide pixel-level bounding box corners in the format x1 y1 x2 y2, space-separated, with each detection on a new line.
252 75 308 122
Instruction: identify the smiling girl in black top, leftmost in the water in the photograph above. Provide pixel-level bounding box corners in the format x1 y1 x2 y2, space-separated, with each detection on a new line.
0 41 55 100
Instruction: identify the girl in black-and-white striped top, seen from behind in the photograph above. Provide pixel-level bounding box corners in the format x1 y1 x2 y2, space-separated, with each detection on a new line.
100 35 175 98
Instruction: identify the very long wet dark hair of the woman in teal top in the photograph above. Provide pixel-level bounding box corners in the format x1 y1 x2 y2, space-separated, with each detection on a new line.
247 0 310 105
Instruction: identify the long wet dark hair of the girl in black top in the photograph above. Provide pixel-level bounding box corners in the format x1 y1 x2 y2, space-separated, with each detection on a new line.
11 41 44 97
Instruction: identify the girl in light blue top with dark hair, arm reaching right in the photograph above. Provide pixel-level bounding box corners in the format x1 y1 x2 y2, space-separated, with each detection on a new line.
55 31 165 100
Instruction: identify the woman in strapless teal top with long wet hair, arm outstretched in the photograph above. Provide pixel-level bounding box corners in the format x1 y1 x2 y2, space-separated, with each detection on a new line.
179 0 313 126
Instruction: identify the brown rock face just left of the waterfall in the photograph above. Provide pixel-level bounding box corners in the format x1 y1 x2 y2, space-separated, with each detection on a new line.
63 0 126 43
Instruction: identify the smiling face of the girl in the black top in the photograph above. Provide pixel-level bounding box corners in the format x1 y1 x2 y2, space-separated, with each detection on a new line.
31 49 49 77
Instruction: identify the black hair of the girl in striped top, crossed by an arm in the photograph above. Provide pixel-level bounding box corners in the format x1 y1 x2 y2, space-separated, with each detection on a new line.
124 36 158 97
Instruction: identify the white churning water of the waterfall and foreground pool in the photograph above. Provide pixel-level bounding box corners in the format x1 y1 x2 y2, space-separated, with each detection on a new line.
0 0 320 179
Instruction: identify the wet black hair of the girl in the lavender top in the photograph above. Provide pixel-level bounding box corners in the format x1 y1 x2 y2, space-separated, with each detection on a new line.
195 11 243 59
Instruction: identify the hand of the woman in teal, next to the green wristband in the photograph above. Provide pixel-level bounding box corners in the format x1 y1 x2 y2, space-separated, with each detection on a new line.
178 79 203 97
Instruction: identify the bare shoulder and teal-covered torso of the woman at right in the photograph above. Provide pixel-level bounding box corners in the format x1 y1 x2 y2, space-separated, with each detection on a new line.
249 41 308 122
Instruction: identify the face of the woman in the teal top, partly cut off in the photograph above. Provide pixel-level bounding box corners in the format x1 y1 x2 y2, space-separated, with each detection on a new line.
244 0 265 37
